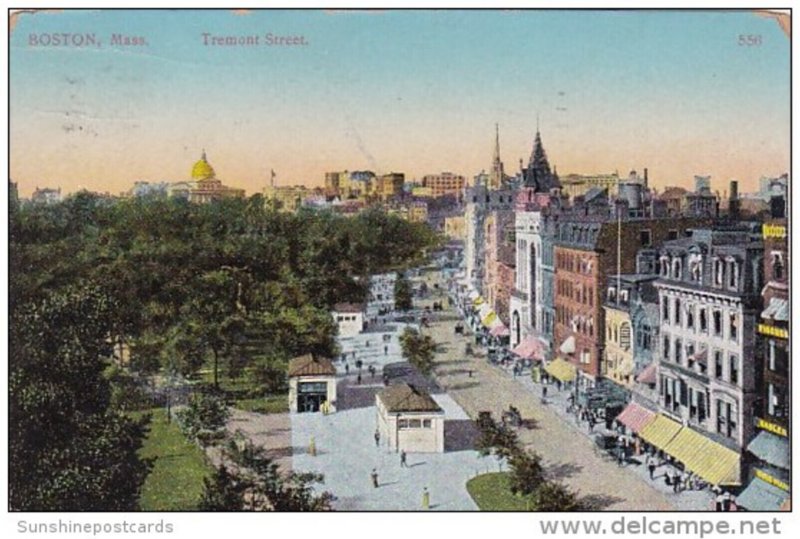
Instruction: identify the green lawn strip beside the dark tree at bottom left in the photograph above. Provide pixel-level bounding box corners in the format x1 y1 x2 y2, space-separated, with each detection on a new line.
139 409 212 511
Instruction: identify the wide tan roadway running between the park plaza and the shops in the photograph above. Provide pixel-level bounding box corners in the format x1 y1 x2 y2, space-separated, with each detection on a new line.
424 272 675 511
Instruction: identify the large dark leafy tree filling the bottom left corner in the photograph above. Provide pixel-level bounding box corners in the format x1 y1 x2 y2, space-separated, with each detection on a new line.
9 286 150 511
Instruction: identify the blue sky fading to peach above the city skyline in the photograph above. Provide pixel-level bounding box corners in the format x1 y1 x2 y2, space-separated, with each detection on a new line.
10 10 790 196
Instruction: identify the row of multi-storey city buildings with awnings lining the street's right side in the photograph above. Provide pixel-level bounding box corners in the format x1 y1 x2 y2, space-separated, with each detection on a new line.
458 125 790 509
